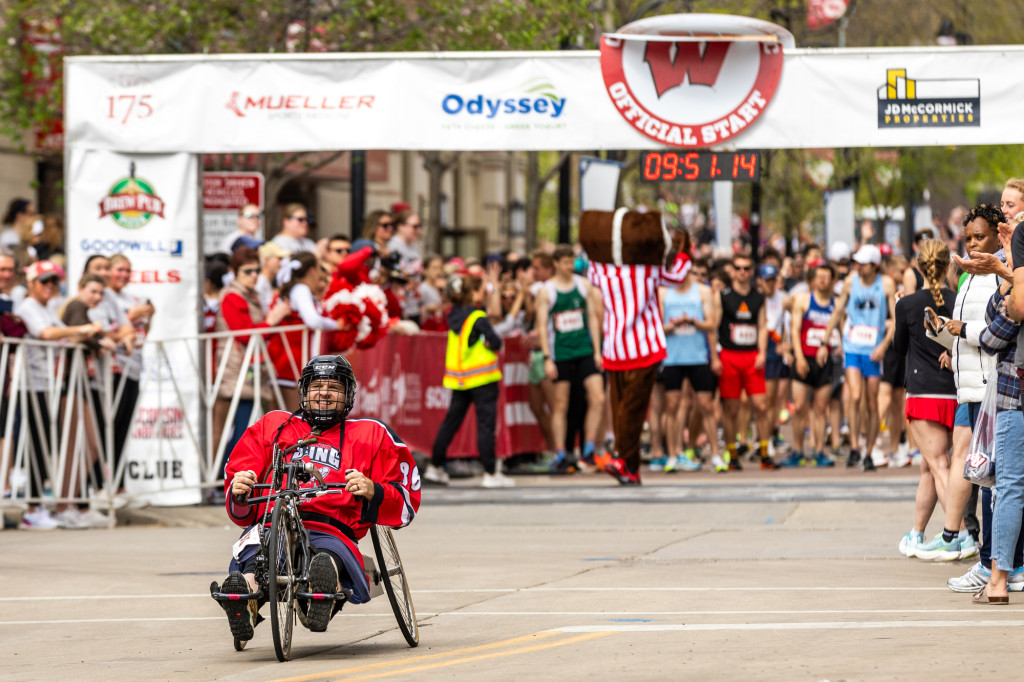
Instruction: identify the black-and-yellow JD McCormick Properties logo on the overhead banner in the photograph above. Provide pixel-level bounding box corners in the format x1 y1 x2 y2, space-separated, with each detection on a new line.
879 69 981 128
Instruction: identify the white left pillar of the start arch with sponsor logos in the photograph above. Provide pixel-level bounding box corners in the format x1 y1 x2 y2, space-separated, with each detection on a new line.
68 150 201 505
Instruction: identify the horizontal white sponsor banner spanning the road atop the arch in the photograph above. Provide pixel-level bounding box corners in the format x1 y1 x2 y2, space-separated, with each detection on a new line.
65 46 1024 153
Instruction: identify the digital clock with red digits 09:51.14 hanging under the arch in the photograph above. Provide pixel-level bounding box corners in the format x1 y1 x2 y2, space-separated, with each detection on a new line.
640 152 761 182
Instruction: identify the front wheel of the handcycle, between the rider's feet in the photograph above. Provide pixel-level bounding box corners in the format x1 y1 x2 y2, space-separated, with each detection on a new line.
266 502 295 663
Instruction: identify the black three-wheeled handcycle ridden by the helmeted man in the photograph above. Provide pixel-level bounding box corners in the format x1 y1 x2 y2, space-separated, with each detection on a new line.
211 435 419 662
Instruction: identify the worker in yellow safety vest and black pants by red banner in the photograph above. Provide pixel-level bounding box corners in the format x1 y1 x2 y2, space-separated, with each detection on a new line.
423 274 515 487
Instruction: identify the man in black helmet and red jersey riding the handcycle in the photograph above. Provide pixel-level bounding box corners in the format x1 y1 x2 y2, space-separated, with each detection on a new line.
217 355 420 641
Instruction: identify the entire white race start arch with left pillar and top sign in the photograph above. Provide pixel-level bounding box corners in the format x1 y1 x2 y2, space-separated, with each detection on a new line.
65 14 1024 499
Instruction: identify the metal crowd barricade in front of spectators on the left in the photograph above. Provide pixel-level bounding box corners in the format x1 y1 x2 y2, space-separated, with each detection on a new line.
0 325 323 524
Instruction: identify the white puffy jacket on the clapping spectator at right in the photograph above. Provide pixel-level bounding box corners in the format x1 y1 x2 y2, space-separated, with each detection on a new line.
935 266 999 404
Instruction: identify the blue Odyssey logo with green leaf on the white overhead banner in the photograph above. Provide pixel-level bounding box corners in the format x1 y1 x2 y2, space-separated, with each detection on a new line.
441 77 568 128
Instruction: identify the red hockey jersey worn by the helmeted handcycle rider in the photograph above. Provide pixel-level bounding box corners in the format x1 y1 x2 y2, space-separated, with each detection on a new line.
224 411 420 563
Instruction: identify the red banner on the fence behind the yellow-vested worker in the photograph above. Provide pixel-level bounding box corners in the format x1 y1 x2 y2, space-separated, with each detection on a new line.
348 333 544 458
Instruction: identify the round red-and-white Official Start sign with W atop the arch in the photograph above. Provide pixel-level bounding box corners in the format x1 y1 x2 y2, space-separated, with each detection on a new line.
601 14 794 147
